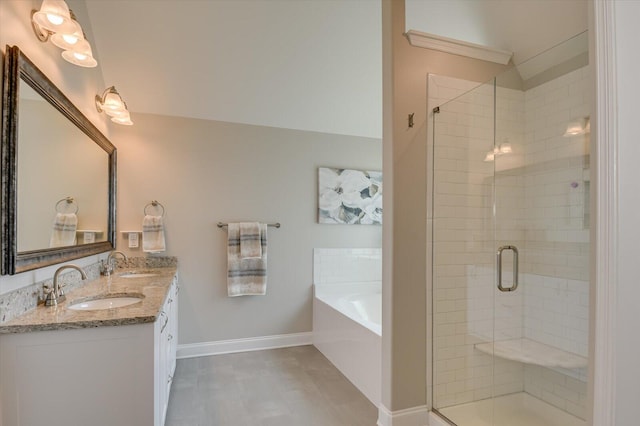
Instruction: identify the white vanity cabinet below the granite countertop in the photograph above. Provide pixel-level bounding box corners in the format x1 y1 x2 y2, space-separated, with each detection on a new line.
0 278 178 426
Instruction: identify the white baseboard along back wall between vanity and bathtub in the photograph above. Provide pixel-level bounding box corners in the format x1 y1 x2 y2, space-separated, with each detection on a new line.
177 333 313 359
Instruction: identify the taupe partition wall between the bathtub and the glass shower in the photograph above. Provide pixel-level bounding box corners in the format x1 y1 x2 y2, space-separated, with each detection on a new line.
382 0 504 411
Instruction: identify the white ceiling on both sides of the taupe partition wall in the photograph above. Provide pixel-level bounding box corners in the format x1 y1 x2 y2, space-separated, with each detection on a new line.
86 0 587 138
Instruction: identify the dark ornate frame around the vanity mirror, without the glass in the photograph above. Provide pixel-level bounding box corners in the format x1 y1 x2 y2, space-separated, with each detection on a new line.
0 46 116 275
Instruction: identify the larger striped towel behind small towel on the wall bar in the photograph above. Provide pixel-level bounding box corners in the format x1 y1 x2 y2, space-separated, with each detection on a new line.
227 223 267 297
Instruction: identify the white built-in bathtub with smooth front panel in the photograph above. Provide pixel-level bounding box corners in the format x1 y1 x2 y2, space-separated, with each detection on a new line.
313 282 382 407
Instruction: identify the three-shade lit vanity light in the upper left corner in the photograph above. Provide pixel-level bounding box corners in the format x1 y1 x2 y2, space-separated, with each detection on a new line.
31 0 98 68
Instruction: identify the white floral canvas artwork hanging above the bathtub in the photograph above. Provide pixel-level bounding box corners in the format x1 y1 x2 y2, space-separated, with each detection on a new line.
318 167 382 225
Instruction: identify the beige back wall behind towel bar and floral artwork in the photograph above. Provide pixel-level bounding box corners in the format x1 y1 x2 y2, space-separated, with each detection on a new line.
113 114 382 344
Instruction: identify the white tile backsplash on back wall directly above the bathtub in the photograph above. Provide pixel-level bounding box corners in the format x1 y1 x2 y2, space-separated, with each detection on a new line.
313 248 382 284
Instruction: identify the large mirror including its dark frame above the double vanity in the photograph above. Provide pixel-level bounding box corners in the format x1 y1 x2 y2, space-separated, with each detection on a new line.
1 46 116 275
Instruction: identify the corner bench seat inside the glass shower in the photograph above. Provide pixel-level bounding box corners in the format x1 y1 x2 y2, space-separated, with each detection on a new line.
475 339 587 368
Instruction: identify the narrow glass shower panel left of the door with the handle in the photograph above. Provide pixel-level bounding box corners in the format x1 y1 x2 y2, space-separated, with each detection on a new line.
431 81 496 426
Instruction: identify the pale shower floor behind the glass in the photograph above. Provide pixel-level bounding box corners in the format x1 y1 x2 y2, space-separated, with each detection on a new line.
440 392 586 426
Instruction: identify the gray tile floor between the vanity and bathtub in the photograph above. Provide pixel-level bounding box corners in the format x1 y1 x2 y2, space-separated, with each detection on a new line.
166 346 378 426
